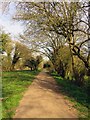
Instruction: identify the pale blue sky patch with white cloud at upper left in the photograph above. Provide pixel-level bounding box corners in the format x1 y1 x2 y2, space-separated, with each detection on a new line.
0 3 24 39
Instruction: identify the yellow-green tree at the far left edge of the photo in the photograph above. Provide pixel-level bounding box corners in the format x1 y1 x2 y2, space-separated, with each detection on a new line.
0 32 13 70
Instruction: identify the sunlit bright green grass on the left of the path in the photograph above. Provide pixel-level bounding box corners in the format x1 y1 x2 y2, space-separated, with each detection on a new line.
2 70 39 118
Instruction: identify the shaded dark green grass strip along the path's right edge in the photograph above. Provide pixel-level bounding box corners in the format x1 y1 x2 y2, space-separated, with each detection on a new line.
51 73 90 118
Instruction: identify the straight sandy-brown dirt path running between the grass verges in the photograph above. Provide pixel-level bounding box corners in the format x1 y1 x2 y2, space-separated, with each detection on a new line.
14 72 77 118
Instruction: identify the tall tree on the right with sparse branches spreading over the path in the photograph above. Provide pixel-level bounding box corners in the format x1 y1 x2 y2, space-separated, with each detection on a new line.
16 2 90 77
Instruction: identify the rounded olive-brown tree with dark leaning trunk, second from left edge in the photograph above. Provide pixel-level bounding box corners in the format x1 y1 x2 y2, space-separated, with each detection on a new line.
11 42 32 70
